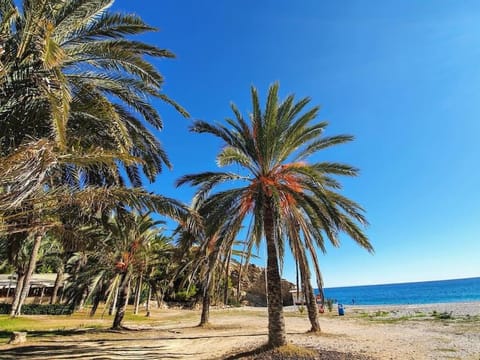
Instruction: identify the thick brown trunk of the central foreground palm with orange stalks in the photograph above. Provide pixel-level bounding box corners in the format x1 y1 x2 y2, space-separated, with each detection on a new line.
264 204 286 348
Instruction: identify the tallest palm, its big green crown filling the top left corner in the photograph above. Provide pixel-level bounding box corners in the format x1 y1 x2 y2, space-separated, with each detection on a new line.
0 0 188 316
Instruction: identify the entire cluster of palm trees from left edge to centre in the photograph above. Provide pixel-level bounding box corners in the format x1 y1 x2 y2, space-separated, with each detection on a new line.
0 0 372 346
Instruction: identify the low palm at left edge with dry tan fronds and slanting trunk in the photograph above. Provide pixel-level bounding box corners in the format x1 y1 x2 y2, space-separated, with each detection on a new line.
0 139 196 314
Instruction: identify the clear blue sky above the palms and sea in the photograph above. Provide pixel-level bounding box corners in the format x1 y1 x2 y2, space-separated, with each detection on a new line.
114 0 480 287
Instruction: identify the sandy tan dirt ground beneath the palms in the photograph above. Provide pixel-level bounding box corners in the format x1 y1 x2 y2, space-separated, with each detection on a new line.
0 304 480 360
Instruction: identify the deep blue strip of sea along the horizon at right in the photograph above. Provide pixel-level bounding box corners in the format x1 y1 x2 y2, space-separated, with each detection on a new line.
317 277 480 305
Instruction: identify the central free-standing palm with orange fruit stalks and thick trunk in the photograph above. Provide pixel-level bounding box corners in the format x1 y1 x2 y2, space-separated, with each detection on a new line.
177 84 372 347
